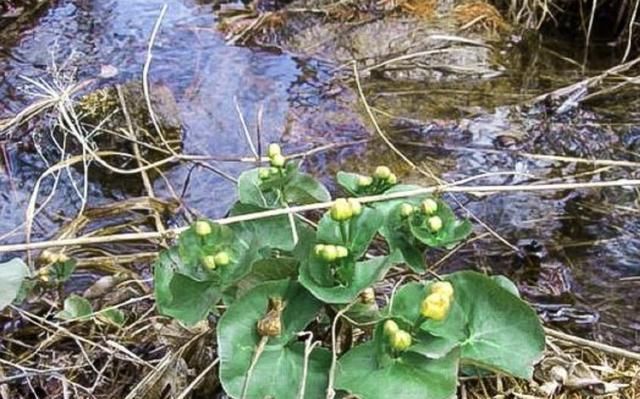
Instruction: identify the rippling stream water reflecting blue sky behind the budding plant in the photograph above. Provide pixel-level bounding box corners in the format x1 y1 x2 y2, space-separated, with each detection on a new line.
0 0 640 349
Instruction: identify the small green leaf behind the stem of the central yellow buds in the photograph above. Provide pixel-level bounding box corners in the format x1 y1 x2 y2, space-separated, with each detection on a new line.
317 206 383 260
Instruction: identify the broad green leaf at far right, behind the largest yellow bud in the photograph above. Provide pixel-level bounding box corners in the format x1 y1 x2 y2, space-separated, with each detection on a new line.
385 271 544 378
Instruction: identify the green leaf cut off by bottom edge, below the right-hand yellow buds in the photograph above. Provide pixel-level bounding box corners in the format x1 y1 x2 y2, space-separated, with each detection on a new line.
336 342 458 399
